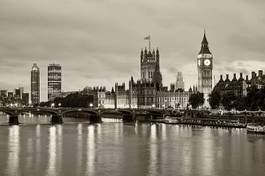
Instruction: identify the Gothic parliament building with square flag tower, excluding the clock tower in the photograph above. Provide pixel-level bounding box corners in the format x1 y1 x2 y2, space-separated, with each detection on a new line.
83 46 192 109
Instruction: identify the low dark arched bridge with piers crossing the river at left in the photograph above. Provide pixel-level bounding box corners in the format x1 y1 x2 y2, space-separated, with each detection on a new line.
0 107 169 125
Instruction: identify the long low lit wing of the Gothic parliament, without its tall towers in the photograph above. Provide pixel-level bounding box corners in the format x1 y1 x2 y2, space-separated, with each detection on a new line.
98 78 192 109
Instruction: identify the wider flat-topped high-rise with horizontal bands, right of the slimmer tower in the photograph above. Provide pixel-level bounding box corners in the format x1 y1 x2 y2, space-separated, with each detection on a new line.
48 64 62 101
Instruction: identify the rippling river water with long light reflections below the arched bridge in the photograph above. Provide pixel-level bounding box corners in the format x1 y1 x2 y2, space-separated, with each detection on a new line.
0 116 265 176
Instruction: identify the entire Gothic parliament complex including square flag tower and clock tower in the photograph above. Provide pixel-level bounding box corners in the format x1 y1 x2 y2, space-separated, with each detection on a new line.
77 33 213 108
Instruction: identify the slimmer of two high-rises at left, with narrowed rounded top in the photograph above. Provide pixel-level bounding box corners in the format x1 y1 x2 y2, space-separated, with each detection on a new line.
31 64 40 105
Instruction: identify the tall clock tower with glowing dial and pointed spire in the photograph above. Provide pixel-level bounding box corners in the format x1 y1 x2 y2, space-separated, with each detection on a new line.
197 32 213 107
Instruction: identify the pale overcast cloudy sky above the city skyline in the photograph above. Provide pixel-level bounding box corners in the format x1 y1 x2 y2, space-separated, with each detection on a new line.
0 0 265 101
